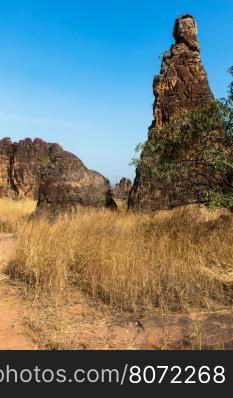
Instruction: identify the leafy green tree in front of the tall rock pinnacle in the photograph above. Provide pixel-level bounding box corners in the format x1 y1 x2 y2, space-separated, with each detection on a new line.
132 67 233 209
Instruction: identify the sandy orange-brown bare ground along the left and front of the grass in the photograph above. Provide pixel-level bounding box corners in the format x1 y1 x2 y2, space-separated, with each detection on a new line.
0 234 233 350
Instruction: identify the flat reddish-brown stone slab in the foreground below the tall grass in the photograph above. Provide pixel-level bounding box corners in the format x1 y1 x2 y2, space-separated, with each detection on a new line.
53 311 233 350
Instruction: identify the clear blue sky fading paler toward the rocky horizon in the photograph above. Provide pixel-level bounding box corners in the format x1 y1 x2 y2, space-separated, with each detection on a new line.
0 0 233 182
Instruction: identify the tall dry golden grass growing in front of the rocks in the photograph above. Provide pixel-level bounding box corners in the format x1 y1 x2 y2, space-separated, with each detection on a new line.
0 197 233 312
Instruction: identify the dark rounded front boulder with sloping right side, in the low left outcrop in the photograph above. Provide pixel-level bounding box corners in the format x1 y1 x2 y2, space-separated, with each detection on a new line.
36 145 117 216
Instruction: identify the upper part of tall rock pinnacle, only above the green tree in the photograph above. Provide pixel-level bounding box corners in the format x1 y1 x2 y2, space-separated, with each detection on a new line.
152 15 213 127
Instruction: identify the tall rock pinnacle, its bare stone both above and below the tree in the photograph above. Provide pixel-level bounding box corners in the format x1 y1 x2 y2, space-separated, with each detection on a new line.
128 15 213 211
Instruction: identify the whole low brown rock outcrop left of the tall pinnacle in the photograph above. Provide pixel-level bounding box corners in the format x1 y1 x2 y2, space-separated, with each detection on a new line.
0 138 116 215
